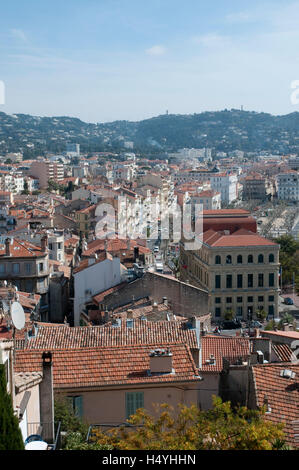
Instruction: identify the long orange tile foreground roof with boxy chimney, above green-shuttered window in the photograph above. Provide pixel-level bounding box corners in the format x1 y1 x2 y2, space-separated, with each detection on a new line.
15 343 200 389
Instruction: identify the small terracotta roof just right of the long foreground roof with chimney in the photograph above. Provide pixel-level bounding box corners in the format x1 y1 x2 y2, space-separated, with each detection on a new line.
201 335 250 372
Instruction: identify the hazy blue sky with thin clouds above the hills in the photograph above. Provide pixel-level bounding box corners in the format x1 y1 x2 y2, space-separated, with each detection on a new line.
0 0 299 122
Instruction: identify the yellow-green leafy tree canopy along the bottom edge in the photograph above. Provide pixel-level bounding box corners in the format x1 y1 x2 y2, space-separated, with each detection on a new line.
93 397 287 450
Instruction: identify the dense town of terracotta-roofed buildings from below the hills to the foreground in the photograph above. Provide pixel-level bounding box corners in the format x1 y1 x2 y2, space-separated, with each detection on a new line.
0 143 299 447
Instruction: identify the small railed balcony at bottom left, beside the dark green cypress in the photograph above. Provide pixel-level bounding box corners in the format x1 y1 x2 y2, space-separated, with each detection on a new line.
25 421 61 450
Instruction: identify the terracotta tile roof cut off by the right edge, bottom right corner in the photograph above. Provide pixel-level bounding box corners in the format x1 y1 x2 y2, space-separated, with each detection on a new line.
252 363 299 447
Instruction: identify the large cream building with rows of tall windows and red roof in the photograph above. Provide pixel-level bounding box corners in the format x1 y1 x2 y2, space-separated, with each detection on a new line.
180 229 280 320
